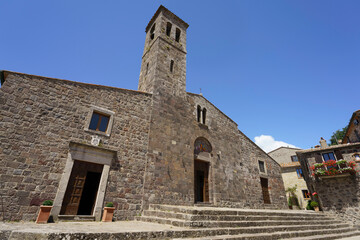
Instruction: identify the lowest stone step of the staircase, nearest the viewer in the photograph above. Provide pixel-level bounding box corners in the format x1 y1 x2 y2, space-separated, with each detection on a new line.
173 228 360 240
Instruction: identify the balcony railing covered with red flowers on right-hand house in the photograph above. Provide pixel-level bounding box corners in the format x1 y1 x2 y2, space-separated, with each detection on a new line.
311 160 356 177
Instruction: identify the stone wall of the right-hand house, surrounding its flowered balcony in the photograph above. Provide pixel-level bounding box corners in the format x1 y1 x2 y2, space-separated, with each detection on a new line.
297 143 360 226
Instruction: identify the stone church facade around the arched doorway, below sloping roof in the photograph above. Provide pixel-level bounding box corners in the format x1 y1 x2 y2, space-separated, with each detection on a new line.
141 89 287 208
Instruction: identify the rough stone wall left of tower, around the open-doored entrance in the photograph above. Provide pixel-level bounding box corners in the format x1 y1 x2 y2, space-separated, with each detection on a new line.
0 72 151 220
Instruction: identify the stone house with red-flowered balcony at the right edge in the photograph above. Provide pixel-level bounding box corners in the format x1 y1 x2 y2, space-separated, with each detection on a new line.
296 139 360 224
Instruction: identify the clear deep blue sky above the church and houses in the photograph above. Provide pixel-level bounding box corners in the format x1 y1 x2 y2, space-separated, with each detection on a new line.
0 0 360 150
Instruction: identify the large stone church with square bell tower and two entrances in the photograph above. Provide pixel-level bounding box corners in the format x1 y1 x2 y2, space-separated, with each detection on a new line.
0 6 287 220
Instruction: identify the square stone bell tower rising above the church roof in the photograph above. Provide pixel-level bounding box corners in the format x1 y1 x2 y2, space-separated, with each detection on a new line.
138 5 189 97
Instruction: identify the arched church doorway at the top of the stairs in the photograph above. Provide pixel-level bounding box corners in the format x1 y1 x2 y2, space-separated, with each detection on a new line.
194 138 212 203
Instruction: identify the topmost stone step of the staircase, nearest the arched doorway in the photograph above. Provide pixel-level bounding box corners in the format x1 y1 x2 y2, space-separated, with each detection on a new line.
149 204 324 217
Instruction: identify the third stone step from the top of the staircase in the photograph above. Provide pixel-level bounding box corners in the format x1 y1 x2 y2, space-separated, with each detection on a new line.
137 216 347 228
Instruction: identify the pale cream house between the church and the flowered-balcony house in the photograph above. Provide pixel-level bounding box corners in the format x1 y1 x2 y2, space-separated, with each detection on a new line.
268 147 310 209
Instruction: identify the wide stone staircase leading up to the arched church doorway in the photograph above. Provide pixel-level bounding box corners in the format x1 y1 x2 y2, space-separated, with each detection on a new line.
136 205 360 240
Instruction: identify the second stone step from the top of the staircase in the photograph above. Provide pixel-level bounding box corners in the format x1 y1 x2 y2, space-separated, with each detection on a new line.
143 210 333 221
